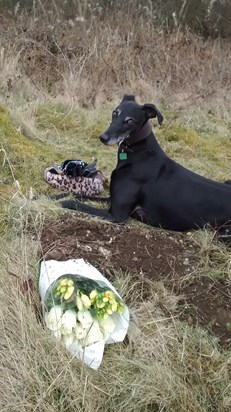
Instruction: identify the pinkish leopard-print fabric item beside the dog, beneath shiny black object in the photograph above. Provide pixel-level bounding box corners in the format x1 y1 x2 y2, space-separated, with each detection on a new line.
44 168 104 196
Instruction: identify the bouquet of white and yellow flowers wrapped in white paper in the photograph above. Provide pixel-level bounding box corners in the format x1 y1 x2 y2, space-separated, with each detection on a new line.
39 259 129 369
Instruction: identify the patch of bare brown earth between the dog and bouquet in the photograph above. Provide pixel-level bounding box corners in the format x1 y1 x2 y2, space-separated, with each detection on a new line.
41 215 231 346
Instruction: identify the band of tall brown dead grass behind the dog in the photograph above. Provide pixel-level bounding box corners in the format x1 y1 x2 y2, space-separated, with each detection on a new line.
0 10 231 116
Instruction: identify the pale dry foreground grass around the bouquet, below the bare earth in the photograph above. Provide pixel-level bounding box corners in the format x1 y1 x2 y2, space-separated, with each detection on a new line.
0 199 231 412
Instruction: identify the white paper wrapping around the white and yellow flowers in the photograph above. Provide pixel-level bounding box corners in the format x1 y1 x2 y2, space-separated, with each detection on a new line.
39 259 129 369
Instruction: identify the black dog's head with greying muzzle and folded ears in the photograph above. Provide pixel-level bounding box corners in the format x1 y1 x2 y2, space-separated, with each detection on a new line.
100 94 163 146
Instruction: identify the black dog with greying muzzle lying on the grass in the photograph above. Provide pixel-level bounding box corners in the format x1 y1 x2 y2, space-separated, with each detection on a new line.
61 95 231 231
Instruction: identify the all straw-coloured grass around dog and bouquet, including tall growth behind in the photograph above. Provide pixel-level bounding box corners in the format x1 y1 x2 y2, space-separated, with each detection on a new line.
0 2 231 412
